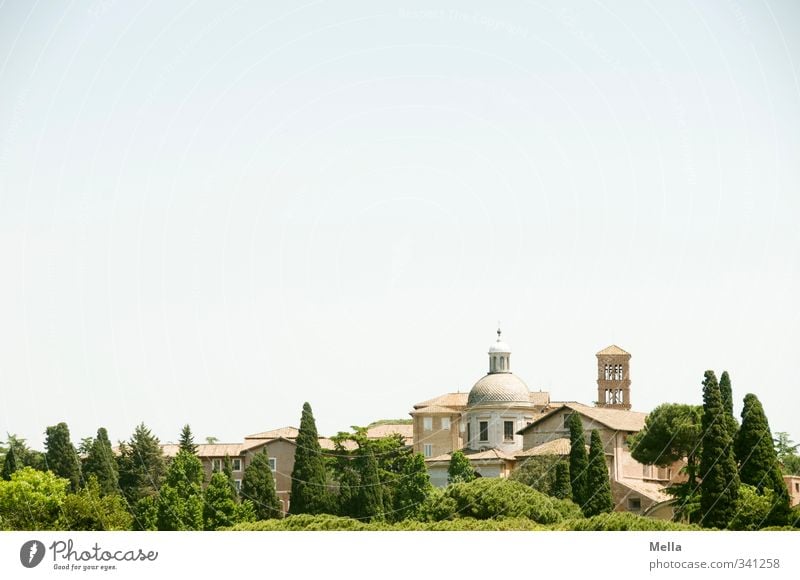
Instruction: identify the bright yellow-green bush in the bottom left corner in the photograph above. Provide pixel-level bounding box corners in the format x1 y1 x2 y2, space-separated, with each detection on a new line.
0 466 69 530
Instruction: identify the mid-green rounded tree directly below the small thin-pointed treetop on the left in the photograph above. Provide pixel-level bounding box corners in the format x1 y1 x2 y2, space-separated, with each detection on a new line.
157 451 203 531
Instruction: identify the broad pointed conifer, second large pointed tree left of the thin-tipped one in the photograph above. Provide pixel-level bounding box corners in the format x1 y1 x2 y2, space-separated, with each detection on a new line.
118 423 166 505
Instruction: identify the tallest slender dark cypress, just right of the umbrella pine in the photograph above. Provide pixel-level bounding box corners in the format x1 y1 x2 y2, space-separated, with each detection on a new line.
700 371 739 528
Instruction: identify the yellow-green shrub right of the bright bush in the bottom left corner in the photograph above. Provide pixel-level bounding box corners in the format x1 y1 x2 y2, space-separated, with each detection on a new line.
57 474 133 531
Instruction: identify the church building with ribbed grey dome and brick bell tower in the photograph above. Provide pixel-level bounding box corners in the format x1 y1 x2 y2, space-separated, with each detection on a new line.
410 329 681 519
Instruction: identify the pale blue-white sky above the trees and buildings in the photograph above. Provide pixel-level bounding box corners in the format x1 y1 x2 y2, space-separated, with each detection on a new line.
0 0 800 448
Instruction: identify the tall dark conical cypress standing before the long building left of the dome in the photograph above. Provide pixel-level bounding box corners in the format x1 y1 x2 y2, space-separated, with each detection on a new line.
289 403 330 514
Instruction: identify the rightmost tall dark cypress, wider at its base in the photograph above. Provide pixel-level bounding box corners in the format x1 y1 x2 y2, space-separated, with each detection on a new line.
734 393 789 525
